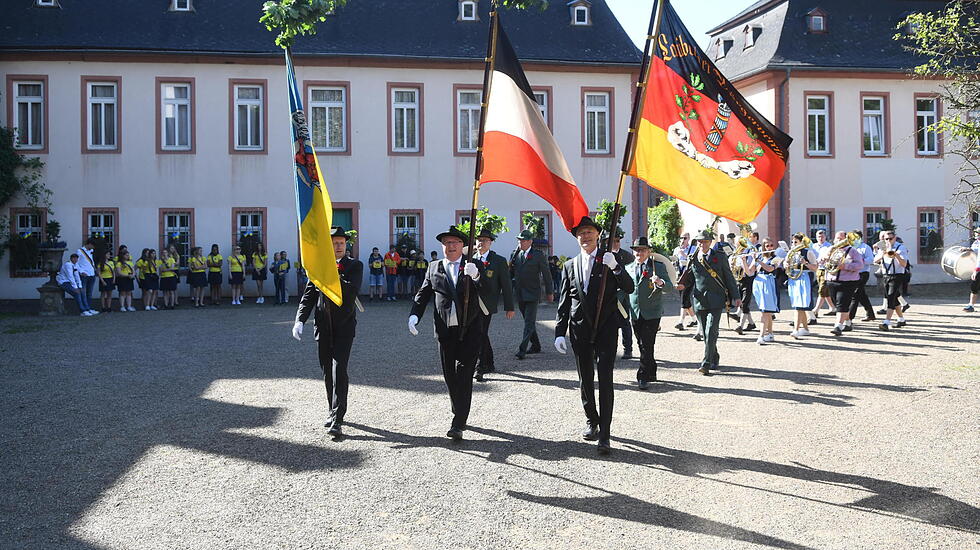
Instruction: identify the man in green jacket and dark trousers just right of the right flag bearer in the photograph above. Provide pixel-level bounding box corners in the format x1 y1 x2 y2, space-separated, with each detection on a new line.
626 237 674 390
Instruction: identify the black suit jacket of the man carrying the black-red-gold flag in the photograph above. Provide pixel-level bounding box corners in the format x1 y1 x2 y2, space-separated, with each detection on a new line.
555 250 634 344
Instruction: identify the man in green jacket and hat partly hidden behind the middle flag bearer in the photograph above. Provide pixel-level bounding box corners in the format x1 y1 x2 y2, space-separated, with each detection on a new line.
473 229 514 382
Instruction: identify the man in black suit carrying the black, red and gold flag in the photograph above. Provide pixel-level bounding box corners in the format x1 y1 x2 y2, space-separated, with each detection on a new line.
555 216 633 454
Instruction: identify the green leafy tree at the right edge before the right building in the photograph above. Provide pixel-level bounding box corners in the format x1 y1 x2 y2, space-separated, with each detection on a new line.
895 0 980 225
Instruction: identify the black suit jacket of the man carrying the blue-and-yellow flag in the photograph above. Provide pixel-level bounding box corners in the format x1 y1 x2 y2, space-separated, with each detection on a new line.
296 257 364 340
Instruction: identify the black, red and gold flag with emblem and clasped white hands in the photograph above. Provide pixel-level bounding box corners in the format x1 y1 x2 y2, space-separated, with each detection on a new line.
630 0 793 223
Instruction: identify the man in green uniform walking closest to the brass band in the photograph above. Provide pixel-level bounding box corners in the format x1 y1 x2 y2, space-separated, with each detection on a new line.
677 230 742 376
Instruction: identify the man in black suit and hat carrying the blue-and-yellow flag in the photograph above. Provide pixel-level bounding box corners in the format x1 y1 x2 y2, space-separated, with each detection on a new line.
293 227 364 437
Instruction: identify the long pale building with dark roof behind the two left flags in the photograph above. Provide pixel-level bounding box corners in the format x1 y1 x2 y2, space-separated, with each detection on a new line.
0 0 640 298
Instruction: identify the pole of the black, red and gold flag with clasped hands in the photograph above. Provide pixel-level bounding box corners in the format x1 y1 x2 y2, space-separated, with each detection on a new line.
592 0 670 344
